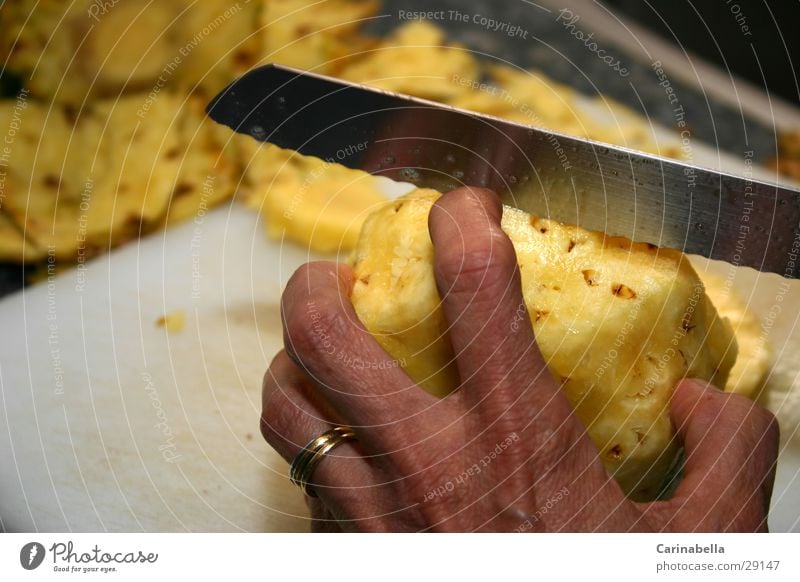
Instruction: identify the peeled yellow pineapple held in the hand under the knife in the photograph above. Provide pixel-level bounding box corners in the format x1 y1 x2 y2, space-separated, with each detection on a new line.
352 190 737 499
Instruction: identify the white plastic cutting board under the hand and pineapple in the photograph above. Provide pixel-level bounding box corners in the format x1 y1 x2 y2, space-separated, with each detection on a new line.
0 148 800 531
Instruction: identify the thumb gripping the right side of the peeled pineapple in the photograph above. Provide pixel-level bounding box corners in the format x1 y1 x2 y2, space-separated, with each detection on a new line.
671 380 778 531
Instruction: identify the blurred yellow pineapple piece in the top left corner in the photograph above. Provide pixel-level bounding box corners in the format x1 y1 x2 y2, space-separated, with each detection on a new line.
0 0 256 108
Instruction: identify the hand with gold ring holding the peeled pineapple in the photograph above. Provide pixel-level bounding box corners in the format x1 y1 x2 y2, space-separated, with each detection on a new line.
261 188 778 531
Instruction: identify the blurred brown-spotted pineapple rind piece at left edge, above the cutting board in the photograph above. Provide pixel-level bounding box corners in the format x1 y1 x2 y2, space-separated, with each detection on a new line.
0 93 180 261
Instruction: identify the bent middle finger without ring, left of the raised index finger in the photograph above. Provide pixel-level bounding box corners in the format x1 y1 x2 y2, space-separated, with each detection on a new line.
282 263 443 453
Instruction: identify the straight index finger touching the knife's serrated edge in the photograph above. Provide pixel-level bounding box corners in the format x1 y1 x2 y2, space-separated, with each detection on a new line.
430 188 572 428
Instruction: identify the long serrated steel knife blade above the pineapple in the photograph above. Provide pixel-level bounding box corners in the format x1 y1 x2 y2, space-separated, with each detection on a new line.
207 65 800 279
